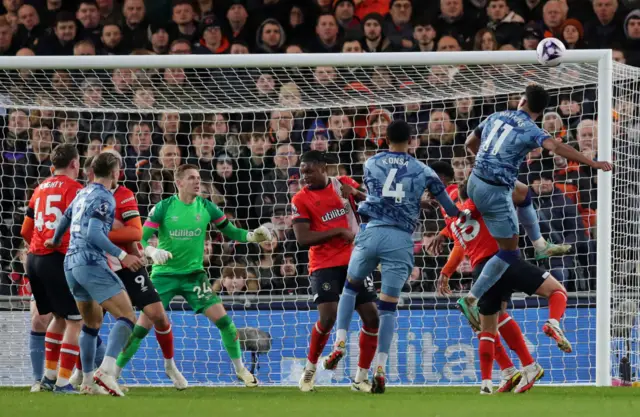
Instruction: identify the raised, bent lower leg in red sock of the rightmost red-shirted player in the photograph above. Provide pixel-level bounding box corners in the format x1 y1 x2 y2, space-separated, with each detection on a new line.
536 274 573 353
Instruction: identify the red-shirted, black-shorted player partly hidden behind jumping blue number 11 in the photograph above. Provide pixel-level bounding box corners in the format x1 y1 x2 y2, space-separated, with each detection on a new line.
429 183 572 394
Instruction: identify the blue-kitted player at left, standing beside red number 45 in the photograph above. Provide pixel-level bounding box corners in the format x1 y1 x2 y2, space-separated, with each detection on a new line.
45 152 143 396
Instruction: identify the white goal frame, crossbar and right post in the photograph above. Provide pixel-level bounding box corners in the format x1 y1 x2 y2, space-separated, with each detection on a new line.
0 50 613 386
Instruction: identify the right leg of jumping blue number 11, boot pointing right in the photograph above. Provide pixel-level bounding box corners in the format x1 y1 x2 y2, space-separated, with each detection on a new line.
512 181 571 260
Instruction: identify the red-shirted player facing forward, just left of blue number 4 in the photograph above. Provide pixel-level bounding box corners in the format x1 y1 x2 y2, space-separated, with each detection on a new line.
292 151 378 392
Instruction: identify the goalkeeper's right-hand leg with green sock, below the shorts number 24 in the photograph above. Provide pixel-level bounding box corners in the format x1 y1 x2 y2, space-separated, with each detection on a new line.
203 303 258 387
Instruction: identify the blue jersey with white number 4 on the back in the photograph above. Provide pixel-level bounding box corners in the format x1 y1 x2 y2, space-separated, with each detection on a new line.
358 151 445 233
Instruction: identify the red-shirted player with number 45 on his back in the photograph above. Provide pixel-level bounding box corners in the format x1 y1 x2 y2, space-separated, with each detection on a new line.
21 144 86 392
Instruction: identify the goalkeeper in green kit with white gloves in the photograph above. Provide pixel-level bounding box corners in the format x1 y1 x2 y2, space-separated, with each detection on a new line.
117 165 271 387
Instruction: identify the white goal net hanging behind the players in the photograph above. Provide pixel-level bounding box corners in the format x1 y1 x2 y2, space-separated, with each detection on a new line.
0 59 640 385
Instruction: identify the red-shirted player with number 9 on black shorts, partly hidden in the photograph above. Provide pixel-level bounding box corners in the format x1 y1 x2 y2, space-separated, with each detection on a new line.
79 150 188 390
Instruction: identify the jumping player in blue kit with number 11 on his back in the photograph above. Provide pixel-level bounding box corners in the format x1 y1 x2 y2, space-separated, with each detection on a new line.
458 85 612 325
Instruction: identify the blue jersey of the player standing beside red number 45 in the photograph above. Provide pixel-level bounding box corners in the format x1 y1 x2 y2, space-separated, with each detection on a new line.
64 183 116 268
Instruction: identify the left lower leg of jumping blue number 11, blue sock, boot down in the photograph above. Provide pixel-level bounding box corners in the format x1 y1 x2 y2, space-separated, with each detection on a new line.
457 235 520 331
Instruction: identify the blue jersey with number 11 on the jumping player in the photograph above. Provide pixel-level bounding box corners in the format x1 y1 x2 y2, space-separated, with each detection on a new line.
473 110 551 187
